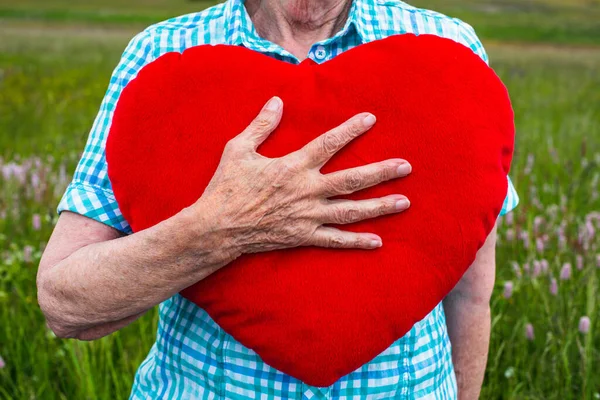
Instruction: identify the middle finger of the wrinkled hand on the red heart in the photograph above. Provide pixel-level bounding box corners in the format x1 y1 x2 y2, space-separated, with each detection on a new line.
320 159 412 197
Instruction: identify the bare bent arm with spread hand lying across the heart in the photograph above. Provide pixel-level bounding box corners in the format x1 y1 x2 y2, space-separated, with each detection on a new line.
37 99 410 339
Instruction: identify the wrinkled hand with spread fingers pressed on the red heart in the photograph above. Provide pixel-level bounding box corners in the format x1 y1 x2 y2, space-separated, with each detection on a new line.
192 97 411 254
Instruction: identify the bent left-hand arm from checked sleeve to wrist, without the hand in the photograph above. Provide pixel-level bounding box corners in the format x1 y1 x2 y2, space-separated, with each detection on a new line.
37 31 233 339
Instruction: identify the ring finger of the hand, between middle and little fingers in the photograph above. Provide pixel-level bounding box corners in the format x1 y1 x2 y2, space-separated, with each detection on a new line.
315 195 410 224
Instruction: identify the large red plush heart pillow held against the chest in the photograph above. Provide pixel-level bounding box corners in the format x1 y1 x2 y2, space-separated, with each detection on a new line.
106 34 514 386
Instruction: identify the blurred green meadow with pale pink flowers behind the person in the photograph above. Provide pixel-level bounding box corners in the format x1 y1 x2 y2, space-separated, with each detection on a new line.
0 0 600 400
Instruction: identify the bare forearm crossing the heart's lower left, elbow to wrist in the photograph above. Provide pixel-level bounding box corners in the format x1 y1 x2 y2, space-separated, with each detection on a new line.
38 203 237 337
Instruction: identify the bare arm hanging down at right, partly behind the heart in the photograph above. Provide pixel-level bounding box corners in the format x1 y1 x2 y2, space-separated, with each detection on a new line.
443 223 496 400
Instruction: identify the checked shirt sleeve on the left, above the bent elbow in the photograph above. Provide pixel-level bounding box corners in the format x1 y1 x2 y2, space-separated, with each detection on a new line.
57 31 154 233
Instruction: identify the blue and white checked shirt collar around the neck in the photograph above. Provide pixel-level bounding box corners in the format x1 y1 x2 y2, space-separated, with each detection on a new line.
224 0 381 49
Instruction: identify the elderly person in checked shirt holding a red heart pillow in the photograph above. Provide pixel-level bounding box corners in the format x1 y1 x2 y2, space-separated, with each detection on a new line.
38 0 518 400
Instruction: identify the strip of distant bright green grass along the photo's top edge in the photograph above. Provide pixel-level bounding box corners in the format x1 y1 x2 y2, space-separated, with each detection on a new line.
0 0 600 45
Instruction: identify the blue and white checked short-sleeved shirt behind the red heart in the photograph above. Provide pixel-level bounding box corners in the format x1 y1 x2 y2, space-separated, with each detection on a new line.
58 0 518 399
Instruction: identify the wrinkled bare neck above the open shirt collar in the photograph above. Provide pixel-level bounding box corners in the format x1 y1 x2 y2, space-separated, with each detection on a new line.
245 0 352 60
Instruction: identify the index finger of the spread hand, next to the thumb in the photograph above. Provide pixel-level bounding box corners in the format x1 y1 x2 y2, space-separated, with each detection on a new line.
299 113 375 169
